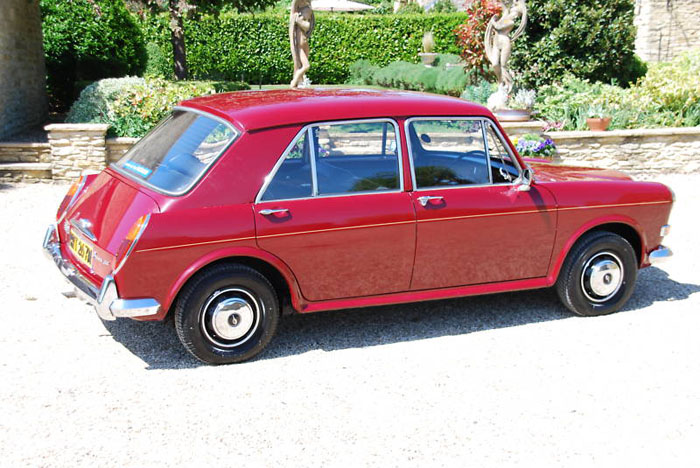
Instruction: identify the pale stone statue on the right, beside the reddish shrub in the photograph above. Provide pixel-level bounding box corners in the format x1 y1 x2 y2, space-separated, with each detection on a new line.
484 0 527 94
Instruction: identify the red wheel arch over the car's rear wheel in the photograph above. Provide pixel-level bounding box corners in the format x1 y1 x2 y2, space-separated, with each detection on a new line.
164 247 303 317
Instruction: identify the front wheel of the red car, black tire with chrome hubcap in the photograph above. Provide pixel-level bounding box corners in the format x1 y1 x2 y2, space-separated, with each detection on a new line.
556 231 638 316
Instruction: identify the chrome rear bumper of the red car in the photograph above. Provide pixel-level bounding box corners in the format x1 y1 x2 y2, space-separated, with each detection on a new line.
43 224 160 320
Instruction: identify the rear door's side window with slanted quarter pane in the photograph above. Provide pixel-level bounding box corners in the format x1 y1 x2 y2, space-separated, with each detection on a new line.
260 120 401 201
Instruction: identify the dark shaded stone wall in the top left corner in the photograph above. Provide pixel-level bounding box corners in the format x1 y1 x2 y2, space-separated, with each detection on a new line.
0 0 47 138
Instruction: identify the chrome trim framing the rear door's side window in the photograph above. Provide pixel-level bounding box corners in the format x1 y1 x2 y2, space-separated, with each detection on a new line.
254 117 404 205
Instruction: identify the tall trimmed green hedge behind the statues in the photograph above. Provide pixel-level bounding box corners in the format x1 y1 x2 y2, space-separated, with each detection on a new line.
143 13 465 84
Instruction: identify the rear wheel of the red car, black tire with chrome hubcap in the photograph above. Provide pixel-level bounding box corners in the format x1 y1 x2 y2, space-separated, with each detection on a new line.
174 264 280 364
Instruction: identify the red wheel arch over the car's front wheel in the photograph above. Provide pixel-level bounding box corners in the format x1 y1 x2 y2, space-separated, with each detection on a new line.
548 216 645 284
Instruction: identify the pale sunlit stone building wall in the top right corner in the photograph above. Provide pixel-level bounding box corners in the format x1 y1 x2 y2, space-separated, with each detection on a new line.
634 0 700 62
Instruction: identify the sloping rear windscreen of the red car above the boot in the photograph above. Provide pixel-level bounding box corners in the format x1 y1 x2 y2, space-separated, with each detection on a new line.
116 110 238 194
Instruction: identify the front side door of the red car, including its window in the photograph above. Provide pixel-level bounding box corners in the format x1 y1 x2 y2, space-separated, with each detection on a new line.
405 118 556 290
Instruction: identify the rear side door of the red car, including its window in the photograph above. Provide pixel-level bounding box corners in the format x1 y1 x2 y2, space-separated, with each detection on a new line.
254 119 415 301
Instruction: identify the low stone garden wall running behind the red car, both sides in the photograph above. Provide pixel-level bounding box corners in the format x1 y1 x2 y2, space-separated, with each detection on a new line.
0 122 700 181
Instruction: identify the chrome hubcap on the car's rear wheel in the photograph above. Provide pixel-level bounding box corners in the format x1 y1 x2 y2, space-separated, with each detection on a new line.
201 288 260 347
